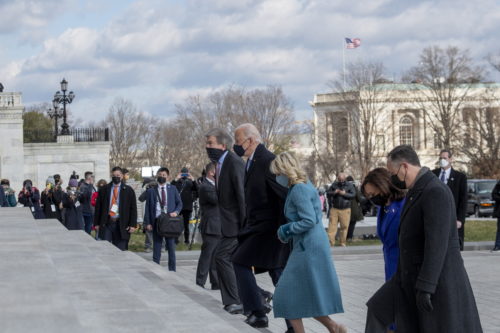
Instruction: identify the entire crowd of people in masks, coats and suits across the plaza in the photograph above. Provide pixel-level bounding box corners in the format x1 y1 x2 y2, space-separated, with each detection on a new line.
0 124 500 333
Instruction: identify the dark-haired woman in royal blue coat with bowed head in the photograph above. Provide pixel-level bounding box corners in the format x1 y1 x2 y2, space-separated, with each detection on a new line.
361 168 405 281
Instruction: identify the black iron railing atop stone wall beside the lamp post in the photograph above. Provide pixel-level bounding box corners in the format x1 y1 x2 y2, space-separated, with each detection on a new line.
24 128 109 143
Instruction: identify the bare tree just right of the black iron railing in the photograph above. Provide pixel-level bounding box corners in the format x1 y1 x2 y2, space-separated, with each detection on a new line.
104 98 147 170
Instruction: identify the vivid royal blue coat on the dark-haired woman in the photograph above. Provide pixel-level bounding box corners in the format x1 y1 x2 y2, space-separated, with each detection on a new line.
377 199 405 281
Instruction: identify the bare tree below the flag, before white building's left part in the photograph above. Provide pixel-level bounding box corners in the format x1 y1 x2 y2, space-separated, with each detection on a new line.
331 61 389 178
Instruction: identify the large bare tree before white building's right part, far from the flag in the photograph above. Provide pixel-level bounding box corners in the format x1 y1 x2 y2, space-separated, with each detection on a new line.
403 46 483 148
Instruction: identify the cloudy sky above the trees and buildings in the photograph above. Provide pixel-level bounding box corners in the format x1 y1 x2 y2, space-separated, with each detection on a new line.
0 0 500 120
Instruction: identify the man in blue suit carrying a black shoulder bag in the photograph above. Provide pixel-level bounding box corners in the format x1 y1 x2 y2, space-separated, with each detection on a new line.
144 167 182 272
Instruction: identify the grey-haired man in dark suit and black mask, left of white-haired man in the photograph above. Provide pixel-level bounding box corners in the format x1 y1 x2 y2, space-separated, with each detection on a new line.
205 128 245 314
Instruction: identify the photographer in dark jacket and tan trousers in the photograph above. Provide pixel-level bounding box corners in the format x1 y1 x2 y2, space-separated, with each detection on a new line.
327 173 356 246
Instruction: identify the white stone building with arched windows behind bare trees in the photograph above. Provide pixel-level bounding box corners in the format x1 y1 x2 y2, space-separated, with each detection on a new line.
310 83 500 180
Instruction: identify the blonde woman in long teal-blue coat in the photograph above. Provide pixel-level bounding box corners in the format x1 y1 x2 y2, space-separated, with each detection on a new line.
271 153 346 333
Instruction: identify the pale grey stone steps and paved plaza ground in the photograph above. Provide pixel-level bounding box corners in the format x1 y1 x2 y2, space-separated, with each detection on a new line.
0 208 500 333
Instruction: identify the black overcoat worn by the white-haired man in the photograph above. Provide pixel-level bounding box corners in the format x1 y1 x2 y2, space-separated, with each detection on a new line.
233 144 290 273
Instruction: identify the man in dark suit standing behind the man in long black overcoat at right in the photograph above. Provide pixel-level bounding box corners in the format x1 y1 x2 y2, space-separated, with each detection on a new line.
432 149 467 251
